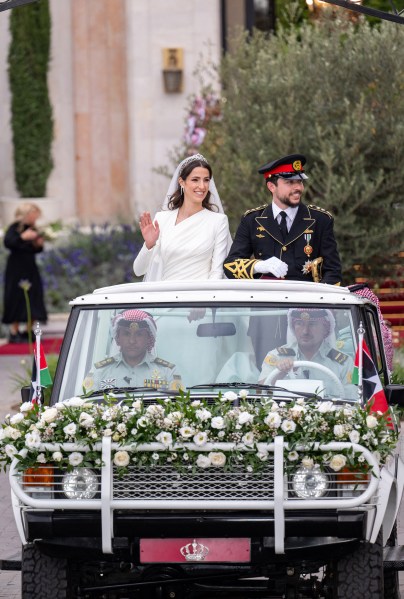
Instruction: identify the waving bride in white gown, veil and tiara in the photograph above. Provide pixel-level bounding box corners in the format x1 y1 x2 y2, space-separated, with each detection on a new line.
133 154 231 281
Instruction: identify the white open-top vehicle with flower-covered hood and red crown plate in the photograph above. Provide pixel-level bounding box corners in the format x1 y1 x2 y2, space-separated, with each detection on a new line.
10 280 404 599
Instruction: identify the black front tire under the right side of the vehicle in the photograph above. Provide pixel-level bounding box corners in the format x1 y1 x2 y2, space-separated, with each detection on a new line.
329 535 384 599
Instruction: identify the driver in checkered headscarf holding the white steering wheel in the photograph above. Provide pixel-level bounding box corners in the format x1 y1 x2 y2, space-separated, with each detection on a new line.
259 308 358 399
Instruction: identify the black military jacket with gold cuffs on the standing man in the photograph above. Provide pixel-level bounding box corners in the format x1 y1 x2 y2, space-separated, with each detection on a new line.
223 204 342 285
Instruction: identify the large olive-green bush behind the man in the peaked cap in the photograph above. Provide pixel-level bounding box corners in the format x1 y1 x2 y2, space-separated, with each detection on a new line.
192 15 404 284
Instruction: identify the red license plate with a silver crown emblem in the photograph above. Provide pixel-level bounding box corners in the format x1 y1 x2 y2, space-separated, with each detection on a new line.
140 537 251 564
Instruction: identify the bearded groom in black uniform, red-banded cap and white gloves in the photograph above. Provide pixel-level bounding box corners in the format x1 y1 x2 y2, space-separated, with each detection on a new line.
223 154 341 285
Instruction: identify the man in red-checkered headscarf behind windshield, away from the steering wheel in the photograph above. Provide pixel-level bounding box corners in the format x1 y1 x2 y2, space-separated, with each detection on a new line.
83 309 181 392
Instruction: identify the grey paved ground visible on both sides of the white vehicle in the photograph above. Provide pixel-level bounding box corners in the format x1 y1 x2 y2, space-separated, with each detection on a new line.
0 315 404 599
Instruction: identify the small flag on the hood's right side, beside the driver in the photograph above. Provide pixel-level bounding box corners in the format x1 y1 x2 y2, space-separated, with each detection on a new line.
352 341 389 414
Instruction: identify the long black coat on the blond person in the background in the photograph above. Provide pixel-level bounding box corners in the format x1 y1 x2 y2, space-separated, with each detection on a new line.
2 223 48 324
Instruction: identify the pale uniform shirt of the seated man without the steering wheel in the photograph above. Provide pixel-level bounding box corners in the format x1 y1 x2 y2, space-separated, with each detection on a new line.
83 353 181 392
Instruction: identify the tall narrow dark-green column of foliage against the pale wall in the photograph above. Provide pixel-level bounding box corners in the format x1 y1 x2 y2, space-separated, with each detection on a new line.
8 0 53 197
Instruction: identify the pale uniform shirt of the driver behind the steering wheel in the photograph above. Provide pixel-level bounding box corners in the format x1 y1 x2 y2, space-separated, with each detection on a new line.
259 342 358 399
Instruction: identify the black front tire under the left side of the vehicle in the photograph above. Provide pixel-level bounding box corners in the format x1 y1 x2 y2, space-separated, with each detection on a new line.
21 545 75 599
